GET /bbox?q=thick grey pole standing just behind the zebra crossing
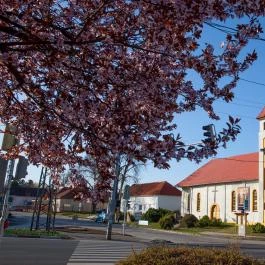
[106,155,120,240]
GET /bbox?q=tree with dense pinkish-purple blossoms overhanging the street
[0,0,265,188]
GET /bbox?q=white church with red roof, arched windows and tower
[177,108,265,224]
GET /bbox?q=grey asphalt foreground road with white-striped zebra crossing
[0,237,145,265]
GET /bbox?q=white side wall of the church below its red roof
[181,181,262,223]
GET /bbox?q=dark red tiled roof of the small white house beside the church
[130,181,181,196]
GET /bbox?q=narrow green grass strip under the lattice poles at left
[4,228,65,238]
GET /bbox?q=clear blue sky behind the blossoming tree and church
[21,17,265,185]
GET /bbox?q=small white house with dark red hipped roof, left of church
[122,181,181,218]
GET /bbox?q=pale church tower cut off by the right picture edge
[257,107,265,224]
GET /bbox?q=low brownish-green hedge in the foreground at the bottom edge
[117,246,264,265]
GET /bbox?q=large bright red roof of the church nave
[177,152,259,187]
